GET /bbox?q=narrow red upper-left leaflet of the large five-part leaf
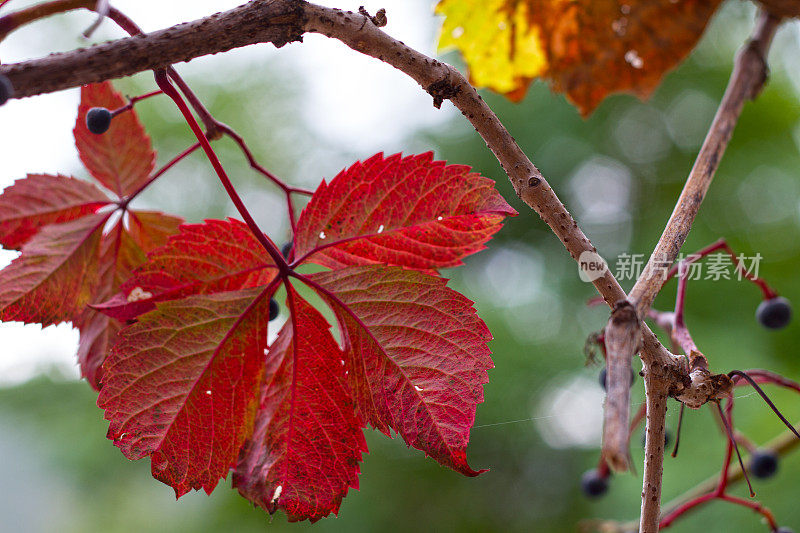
[95,219,275,320]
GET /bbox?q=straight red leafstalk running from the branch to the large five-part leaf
[155,70,289,270]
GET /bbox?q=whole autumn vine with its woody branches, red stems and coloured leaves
[0,0,800,533]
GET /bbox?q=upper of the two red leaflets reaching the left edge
[0,174,109,250]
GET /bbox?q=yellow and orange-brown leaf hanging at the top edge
[436,0,720,115]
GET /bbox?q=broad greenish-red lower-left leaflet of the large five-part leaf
[97,288,271,496]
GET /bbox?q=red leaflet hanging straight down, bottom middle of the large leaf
[233,286,367,522]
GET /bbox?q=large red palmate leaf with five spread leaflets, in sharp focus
[97,154,514,521]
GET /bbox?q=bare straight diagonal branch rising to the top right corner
[630,13,780,316]
